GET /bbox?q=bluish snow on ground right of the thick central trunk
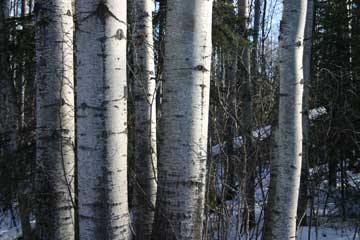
[208,164,360,240]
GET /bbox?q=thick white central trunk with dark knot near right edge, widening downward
[152,0,212,240]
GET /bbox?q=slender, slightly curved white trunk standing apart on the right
[264,0,307,240]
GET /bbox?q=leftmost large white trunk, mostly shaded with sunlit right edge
[35,0,75,240]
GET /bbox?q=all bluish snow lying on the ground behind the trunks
[0,164,360,240]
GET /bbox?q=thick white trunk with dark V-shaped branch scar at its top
[76,0,129,240]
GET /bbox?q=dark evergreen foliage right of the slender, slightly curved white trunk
[310,0,360,219]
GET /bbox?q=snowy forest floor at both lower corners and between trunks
[0,163,360,240]
